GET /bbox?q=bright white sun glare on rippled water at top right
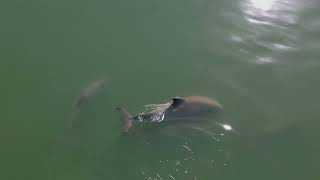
[236,0,304,64]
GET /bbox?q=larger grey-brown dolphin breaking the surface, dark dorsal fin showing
[117,96,223,135]
